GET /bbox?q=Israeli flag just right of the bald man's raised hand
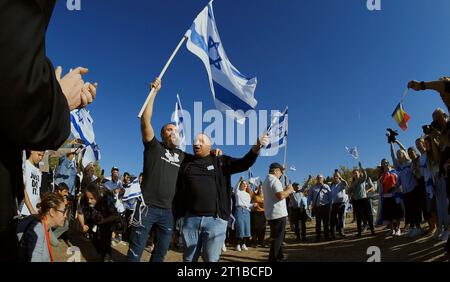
[261,108,288,156]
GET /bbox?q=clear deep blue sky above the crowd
[47,0,450,184]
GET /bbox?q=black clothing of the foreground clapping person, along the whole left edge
[0,0,70,261]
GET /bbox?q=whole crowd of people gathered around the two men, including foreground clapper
[0,0,450,262]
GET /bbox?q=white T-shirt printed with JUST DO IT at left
[20,160,42,215]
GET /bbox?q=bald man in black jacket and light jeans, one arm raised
[174,134,269,262]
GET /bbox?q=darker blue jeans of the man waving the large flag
[127,202,173,262]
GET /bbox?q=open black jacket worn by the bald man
[173,150,258,221]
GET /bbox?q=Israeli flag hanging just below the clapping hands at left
[70,109,95,145]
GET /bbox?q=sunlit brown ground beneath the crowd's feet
[54,215,448,262]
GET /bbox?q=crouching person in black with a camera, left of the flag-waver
[78,183,120,262]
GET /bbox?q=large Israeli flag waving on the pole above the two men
[186,1,258,124]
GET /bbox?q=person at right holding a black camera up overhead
[390,133,422,237]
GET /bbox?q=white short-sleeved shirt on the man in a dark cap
[263,174,288,220]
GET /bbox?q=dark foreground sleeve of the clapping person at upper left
[0,0,70,150]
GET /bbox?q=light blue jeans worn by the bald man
[182,215,228,262]
